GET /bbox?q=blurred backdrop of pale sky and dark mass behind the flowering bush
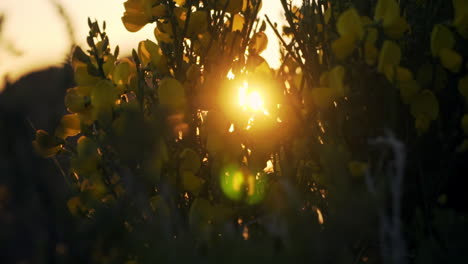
[0,0,292,264]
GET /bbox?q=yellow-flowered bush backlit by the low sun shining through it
[33,0,468,263]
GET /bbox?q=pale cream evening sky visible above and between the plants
[0,0,296,91]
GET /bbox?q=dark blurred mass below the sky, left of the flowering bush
[0,64,74,263]
